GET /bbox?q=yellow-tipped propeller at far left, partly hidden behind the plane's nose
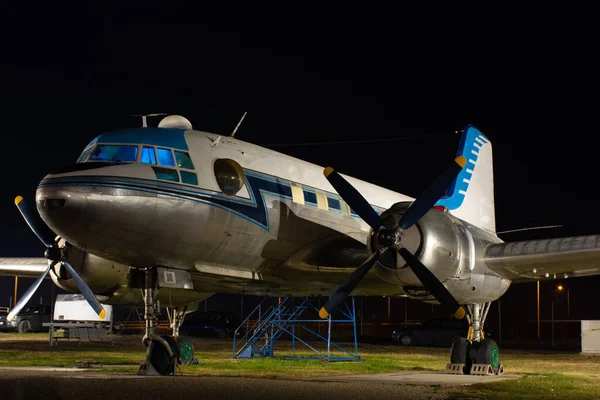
[6,196,106,321]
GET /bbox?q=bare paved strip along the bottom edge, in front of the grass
[0,368,509,400]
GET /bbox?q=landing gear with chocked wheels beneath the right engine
[446,303,504,375]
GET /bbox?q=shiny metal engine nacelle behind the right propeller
[369,203,510,304]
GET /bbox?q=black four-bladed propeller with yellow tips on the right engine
[319,156,467,318]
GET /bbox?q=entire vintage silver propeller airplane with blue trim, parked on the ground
[0,115,600,374]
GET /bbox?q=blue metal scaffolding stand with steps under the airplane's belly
[232,297,361,362]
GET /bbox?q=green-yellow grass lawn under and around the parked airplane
[0,333,600,399]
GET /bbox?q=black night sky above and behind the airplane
[0,2,600,322]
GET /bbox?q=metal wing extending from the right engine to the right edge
[484,235,600,282]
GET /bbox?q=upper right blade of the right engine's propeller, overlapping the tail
[400,156,467,229]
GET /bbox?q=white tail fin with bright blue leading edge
[437,125,496,233]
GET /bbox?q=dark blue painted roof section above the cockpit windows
[88,128,189,150]
